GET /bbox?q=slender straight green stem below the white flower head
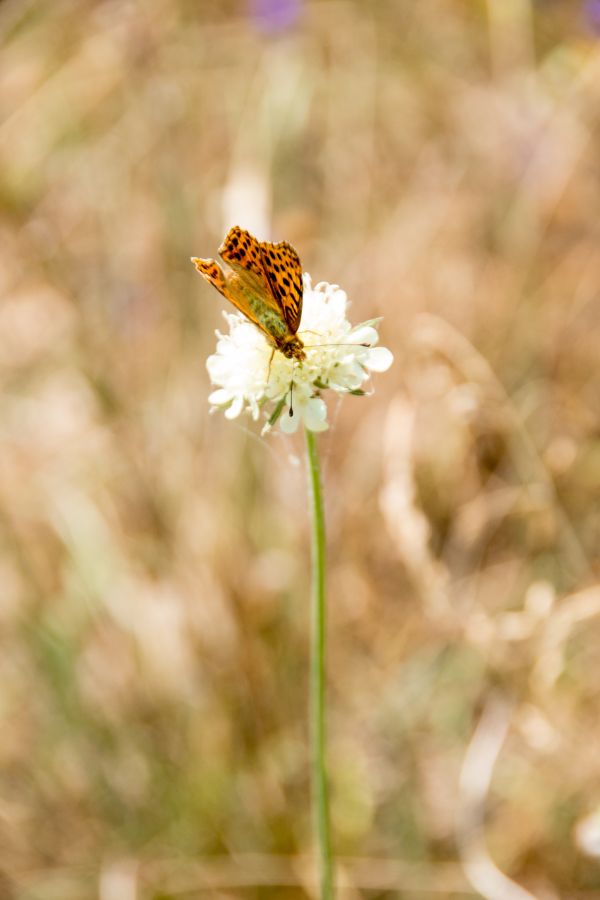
[305,428,333,900]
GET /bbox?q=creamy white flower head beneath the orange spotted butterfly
[206,274,394,434]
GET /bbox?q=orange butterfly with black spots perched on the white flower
[192,225,306,362]
